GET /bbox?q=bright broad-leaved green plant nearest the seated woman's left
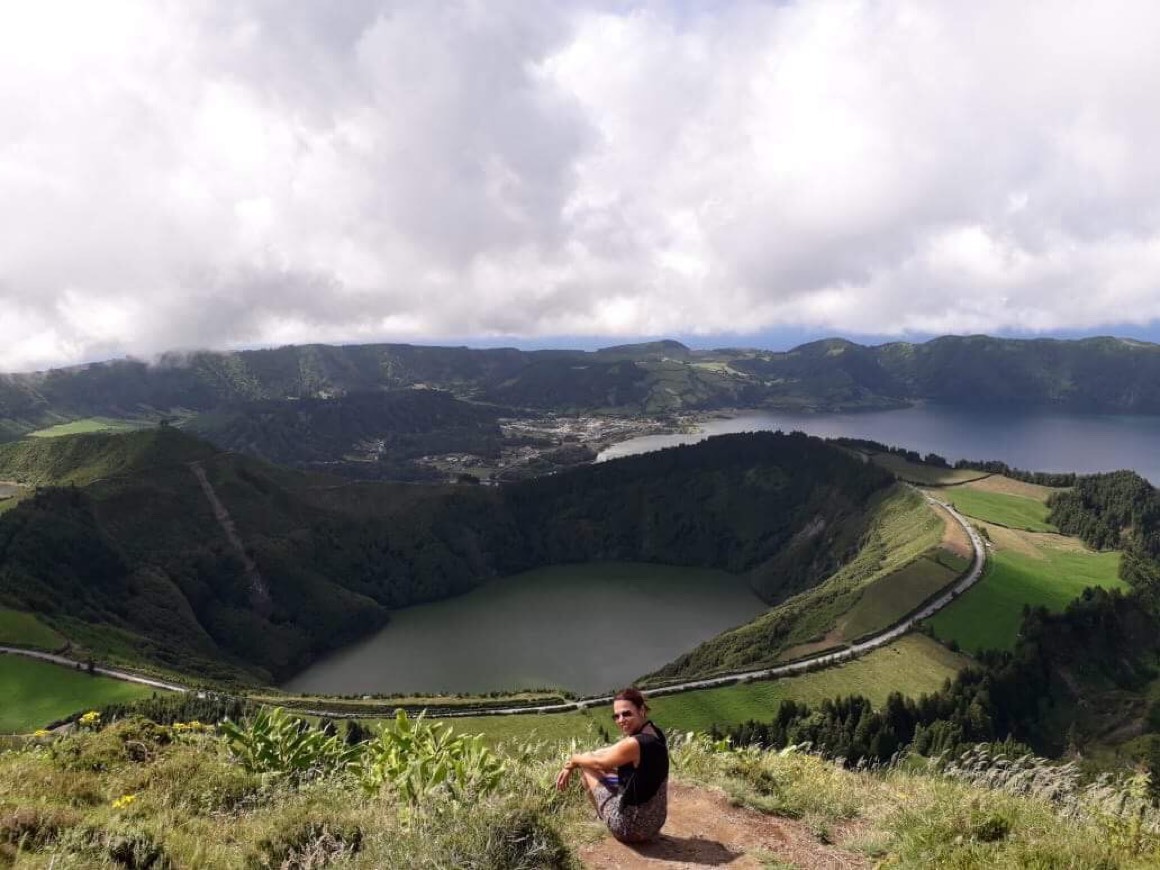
[360,710,507,807]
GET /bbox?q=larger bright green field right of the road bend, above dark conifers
[929,546,1125,652]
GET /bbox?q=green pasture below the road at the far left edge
[0,653,157,733]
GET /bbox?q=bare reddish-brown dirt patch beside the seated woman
[580,783,871,870]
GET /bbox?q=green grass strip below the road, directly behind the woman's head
[444,635,971,741]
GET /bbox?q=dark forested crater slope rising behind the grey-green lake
[0,427,890,679]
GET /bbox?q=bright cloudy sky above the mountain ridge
[0,0,1160,370]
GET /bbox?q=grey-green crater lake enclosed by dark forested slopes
[283,563,764,695]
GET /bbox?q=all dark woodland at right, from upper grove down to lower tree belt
[728,472,1160,792]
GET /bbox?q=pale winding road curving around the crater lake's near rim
[0,495,987,718]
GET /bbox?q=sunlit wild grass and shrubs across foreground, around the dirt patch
[0,720,1160,870]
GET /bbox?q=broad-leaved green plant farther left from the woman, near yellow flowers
[219,708,362,778]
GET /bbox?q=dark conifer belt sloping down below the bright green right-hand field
[723,589,1160,774]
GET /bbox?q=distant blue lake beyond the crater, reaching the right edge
[600,405,1160,484]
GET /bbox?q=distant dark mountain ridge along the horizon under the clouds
[0,335,1160,437]
